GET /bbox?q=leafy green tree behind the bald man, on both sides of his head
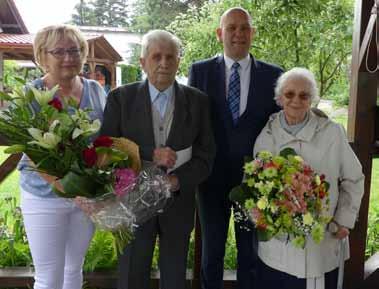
[169,0,353,96]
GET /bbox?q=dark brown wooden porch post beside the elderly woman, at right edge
[344,0,379,289]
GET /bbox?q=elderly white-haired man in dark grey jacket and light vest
[101,30,215,289]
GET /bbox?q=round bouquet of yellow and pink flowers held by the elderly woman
[230,148,330,248]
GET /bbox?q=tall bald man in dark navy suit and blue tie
[189,7,282,289]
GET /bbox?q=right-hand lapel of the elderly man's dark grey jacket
[166,81,188,147]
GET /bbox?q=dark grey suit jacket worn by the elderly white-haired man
[101,81,215,196]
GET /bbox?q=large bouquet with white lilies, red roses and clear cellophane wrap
[0,86,171,251]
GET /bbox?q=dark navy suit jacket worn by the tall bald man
[188,56,282,192]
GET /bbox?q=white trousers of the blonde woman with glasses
[21,192,94,289]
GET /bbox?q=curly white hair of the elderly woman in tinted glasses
[274,67,320,106]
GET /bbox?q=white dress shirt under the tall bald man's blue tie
[224,54,251,116]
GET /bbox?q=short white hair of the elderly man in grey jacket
[141,29,182,58]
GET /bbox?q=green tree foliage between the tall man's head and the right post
[253,0,353,97]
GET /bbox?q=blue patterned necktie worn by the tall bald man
[227,62,241,125]
